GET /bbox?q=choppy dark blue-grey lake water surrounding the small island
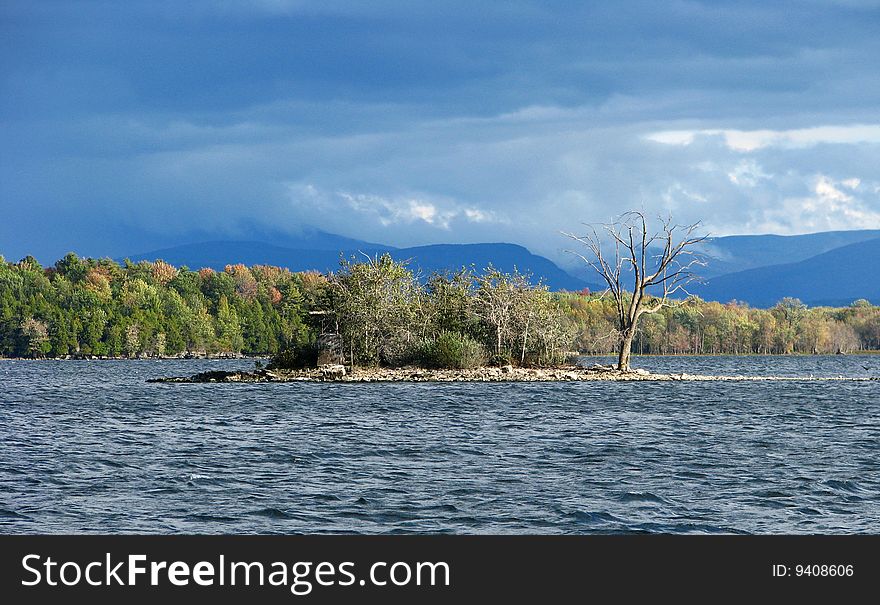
[0,356,880,533]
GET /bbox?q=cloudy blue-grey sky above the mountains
[0,0,880,261]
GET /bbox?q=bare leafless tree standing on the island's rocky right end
[564,211,706,371]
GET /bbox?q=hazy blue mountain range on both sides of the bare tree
[120,229,880,307]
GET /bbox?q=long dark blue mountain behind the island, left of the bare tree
[122,239,597,290]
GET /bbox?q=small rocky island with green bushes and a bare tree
[150,212,870,383]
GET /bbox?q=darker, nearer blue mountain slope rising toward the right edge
[690,237,880,307]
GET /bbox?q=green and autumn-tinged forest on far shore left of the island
[0,254,316,357]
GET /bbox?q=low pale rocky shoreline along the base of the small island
[147,365,880,383]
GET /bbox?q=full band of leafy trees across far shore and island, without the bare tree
[0,254,880,367]
